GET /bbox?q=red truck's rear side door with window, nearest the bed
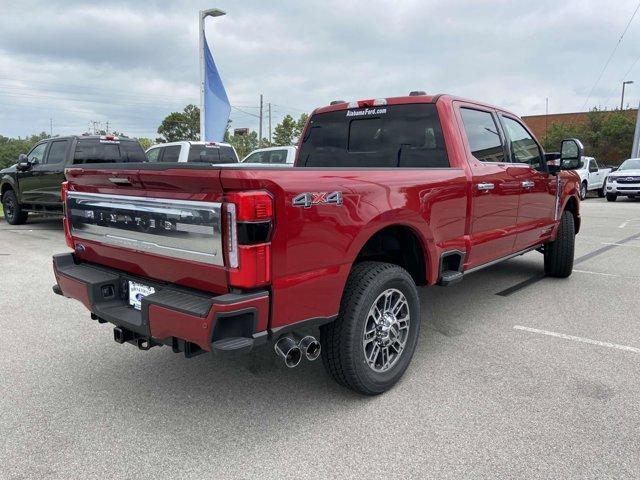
[459,104,521,268]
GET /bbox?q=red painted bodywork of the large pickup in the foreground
[60,96,577,334]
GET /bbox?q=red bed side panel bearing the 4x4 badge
[220,168,467,328]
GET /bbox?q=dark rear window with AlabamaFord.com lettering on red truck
[299,104,449,168]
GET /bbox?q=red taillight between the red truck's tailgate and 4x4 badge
[225,191,273,288]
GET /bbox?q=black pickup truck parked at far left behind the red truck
[0,135,146,225]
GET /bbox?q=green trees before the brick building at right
[544,108,635,165]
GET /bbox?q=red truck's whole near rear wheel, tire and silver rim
[320,262,420,395]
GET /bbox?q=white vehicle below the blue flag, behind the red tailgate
[146,141,238,163]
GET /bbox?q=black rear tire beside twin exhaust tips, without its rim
[320,262,420,395]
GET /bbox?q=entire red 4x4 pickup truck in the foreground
[53,92,583,395]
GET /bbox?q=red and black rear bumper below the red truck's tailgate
[53,253,269,355]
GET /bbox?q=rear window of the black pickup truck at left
[73,138,147,164]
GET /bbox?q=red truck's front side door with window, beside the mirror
[500,114,558,251]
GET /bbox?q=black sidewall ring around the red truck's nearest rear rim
[350,269,420,392]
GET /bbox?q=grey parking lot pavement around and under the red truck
[0,198,640,479]
